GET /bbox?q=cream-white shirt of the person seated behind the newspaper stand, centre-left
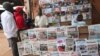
[35,15,48,27]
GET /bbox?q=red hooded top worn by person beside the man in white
[14,7,26,30]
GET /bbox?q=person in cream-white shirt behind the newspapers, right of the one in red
[35,8,48,27]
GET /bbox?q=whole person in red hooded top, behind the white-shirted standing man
[14,7,27,41]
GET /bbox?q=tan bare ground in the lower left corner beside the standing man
[0,30,12,56]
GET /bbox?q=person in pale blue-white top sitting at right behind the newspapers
[71,12,86,26]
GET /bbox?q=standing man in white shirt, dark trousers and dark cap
[1,2,19,56]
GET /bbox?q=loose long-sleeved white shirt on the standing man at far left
[1,11,17,38]
